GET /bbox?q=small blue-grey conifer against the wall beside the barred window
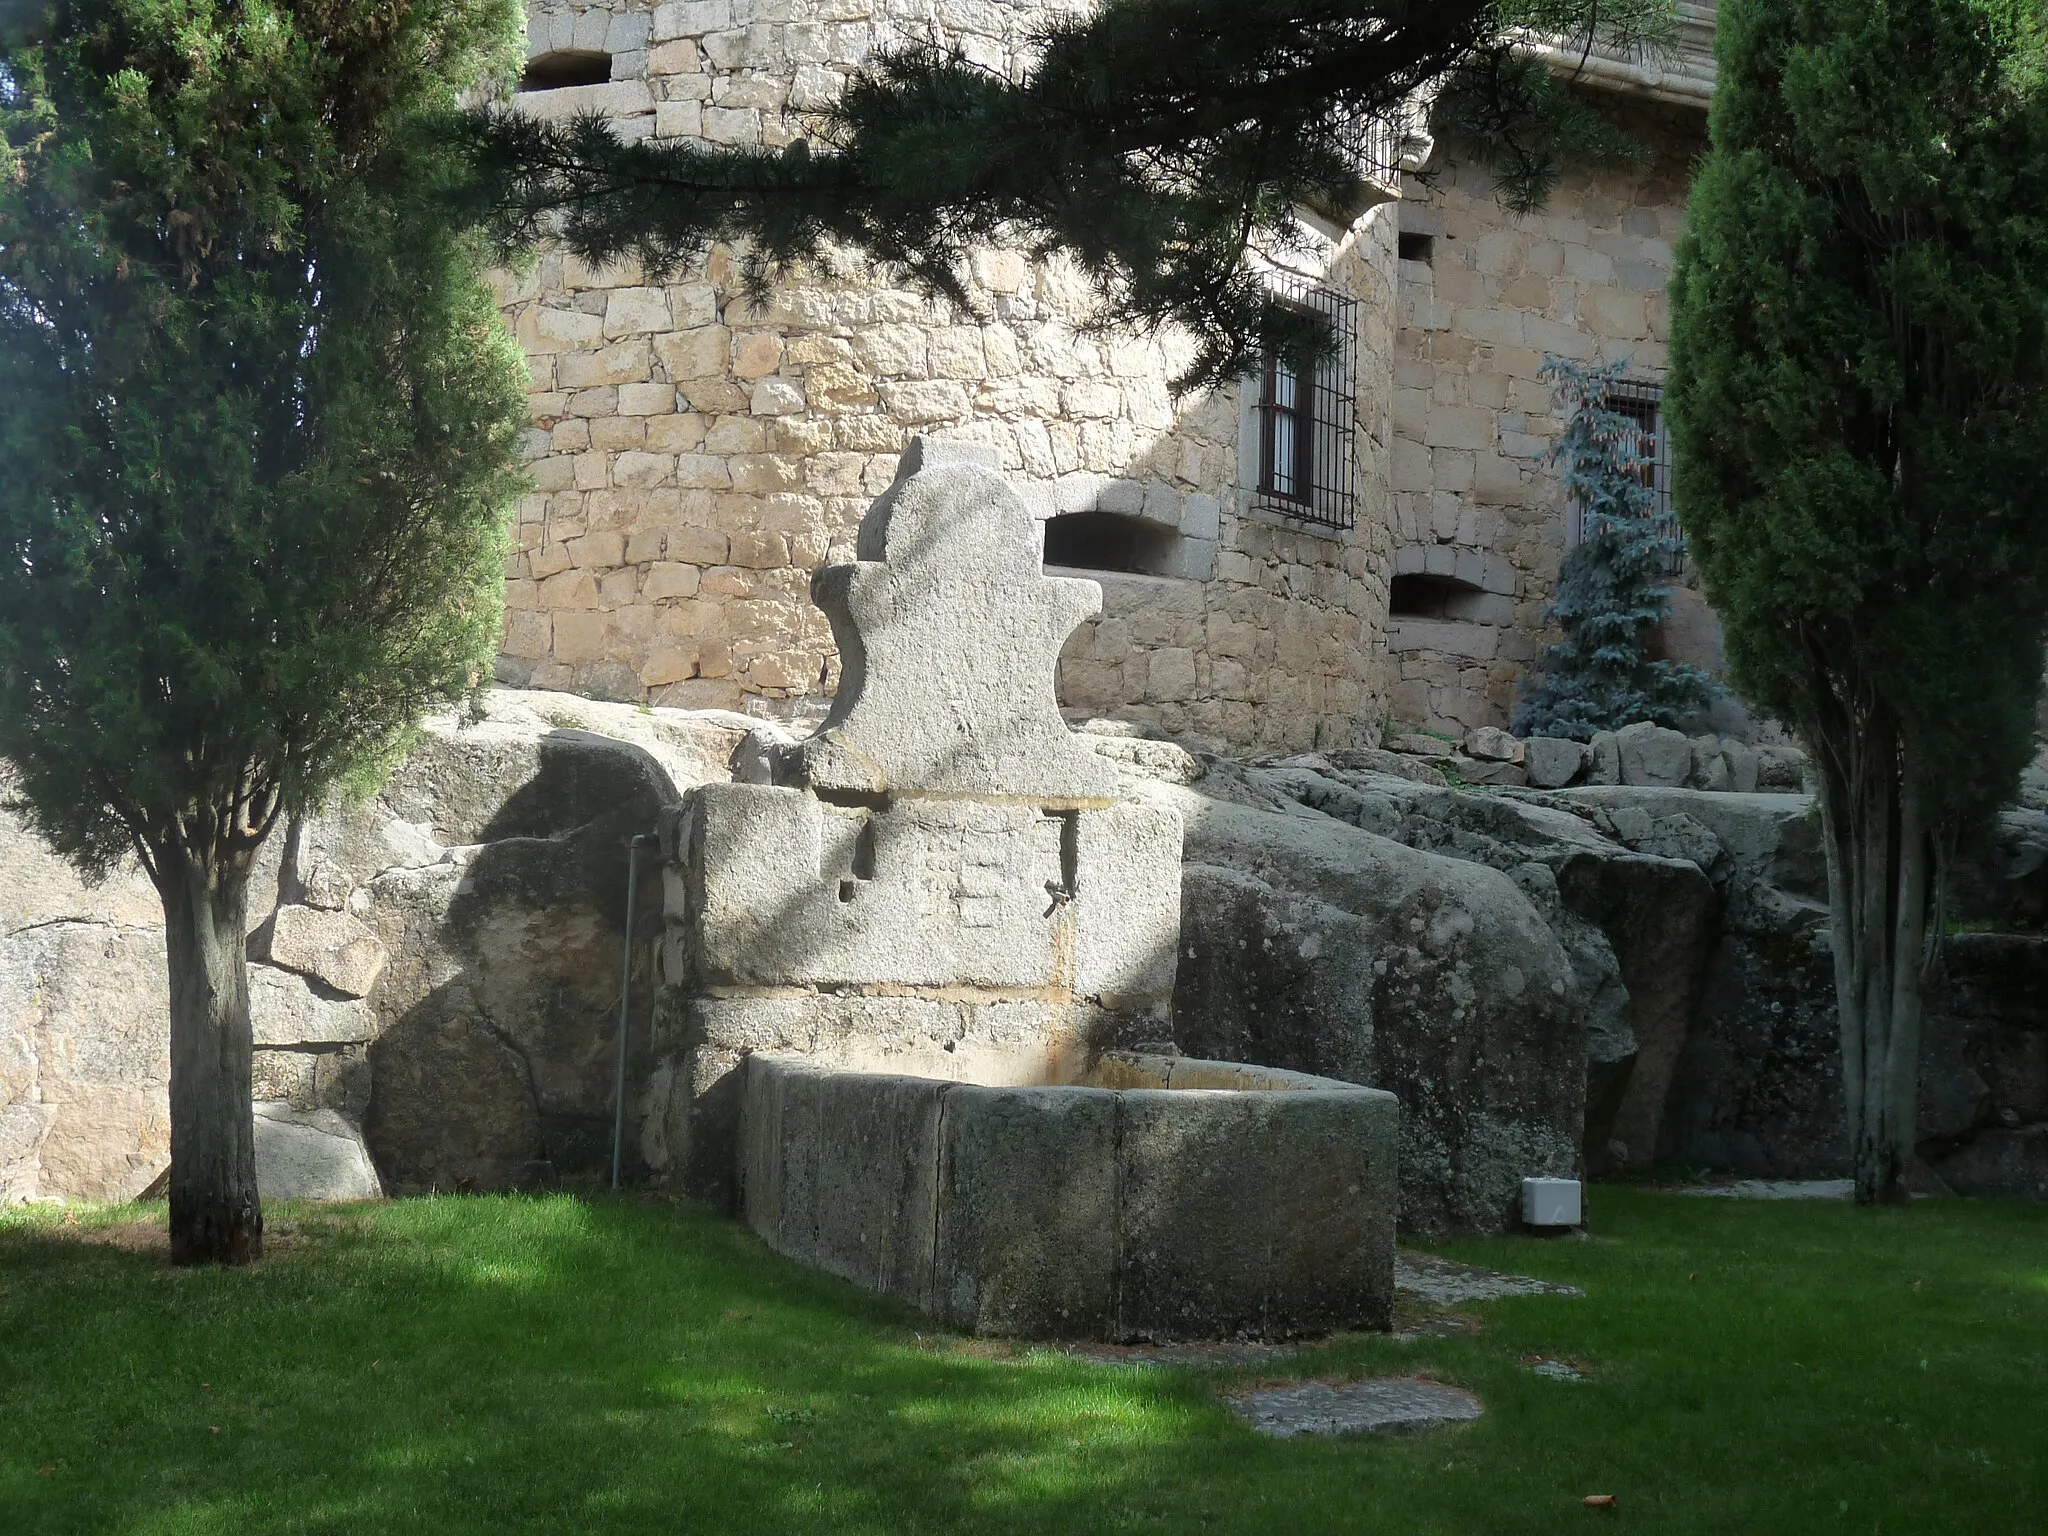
[1513,356,1714,741]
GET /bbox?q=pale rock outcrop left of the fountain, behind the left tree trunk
[0,692,752,1200]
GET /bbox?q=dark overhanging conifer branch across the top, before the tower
[469,0,1671,387]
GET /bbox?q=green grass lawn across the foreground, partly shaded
[0,1190,2048,1536]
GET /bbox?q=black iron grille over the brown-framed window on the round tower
[1253,274,1358,528]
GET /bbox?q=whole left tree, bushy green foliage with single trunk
[0,0,526,1262]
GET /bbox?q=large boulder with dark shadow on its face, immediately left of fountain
[335,692,752,1192]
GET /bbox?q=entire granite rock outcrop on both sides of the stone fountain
[12,692,2048,1231]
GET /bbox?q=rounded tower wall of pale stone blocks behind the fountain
[500,0,1395,745]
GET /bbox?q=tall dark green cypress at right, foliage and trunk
[1667,0,2048,1202]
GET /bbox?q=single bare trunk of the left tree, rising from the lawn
[156,858,262,1264]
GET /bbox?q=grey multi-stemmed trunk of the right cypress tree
[1817,711,1935,1204]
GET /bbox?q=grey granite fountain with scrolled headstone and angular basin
[662,438,1397,1339]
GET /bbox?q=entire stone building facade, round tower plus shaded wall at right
[500,0,1712,750]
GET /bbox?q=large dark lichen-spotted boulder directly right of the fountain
[1151,776,1585,1235]
